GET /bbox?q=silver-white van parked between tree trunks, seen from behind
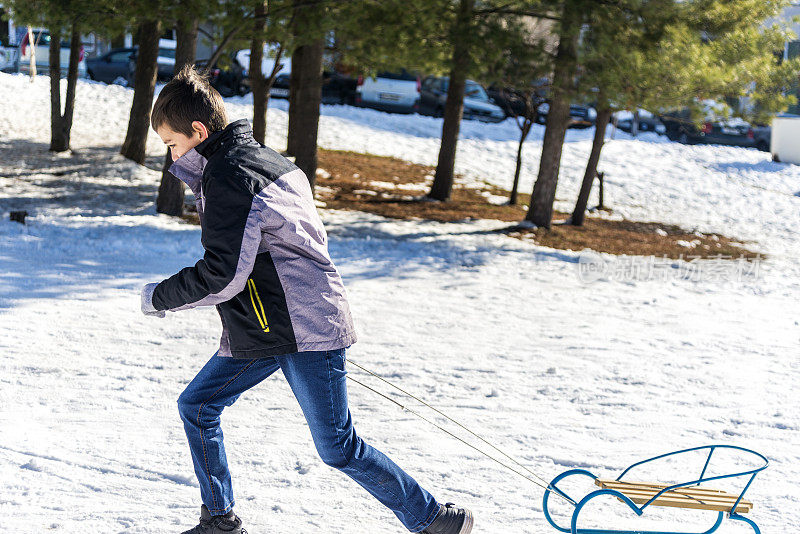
[355,70,420,113]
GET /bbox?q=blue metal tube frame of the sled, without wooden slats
[542,445,769,534]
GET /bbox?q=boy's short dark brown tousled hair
[150,65,228,136]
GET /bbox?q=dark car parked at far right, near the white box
[660,110,769,149]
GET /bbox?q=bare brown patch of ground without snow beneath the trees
[316,150,757,259]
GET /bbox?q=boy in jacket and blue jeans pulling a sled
[141,67,472,534]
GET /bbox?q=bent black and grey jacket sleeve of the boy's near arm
[152,176,261,311]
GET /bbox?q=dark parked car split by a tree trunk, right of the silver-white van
[417,76,506,122]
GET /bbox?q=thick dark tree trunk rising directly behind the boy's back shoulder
[287,39,325,189]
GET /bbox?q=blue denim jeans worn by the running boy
[178,349,439,532]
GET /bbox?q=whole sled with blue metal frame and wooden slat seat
[542,445,769,534]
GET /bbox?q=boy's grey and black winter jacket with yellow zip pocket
[145,120,356,358]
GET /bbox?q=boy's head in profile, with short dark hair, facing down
[150,65,228,161]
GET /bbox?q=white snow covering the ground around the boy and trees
[0,74,800,534]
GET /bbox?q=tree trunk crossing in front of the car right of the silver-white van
[428,0,475,201]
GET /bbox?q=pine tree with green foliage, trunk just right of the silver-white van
[337,0,557,201]
